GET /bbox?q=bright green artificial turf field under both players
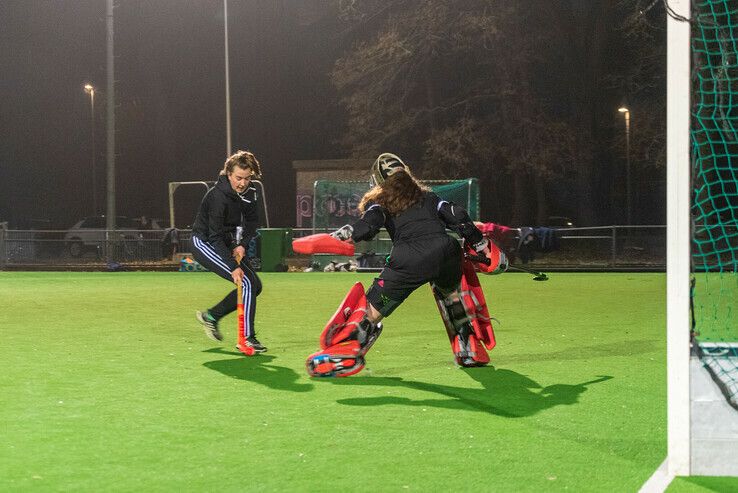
[0,272,732,492]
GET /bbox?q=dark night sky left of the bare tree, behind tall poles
[0,0,344,228]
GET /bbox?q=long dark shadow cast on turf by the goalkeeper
[327,366,613,418]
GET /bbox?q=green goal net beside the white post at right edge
[691,0,738,408]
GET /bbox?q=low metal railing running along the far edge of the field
[0,225,666,270]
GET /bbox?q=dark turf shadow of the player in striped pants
[202,348,314,392]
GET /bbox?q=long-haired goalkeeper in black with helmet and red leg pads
[307,153,498,376]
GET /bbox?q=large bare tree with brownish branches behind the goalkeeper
[331,0,663,224]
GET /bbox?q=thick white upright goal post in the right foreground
[666,0,691,477]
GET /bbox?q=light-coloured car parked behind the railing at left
[64,216,162,257]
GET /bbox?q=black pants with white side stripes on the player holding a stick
[192,235,261,337]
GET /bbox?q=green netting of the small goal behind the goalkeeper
[313,178,479,229]
